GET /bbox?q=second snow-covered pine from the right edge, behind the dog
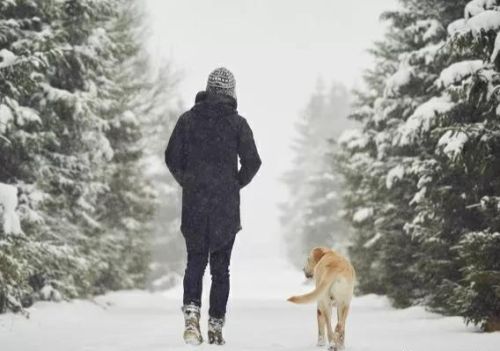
[338,0,464,306]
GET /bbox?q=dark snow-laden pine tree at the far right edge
[419,0,500,331]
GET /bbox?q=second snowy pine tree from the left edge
[36,0,124,297]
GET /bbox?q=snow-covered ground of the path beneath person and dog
[0,258,500,351]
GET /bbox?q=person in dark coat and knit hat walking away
[165,67,261,345]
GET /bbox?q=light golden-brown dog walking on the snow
[288,247,356,350]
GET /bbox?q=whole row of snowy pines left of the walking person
[0,0,179,312]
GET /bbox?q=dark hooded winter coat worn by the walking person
[165,93,261,251]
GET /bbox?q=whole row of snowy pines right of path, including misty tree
[284,0,500,331]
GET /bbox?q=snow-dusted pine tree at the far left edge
[0,1,75,312]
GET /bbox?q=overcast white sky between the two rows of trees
[146,0,396,260]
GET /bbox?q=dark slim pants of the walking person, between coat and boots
[183,238,234,318]
